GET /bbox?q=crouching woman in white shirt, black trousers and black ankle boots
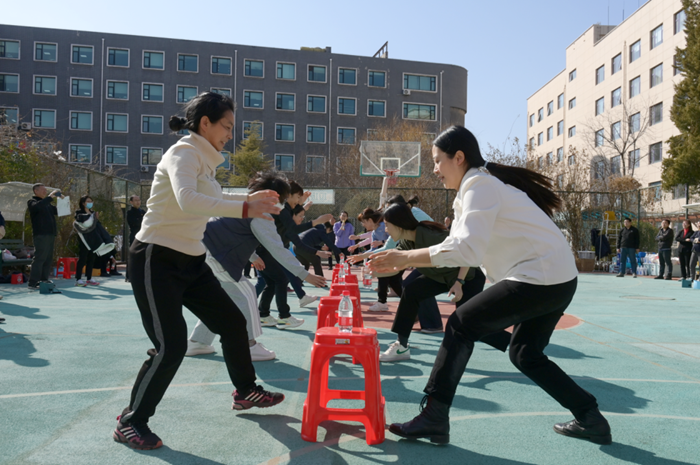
[370,126,612,444]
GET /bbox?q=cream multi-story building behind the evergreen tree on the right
[527,0,685,211]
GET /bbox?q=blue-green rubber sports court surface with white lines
[0,274,700,465]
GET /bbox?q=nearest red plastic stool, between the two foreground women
[301,327,386,445]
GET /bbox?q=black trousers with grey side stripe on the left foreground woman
[122,240,255,423]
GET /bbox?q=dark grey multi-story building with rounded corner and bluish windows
[0,25,467,185]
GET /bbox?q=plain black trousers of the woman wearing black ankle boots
[425,278,598,416]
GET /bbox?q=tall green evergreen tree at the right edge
[661,0,700,190]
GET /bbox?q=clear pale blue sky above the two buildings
[0,0,645,152]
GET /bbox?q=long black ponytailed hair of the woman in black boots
[433,126,561,217]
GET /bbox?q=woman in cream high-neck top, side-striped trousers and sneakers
[113,92,284,450]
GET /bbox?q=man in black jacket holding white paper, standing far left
[27,183,63,290]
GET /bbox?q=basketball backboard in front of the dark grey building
[360,140,421,178]
